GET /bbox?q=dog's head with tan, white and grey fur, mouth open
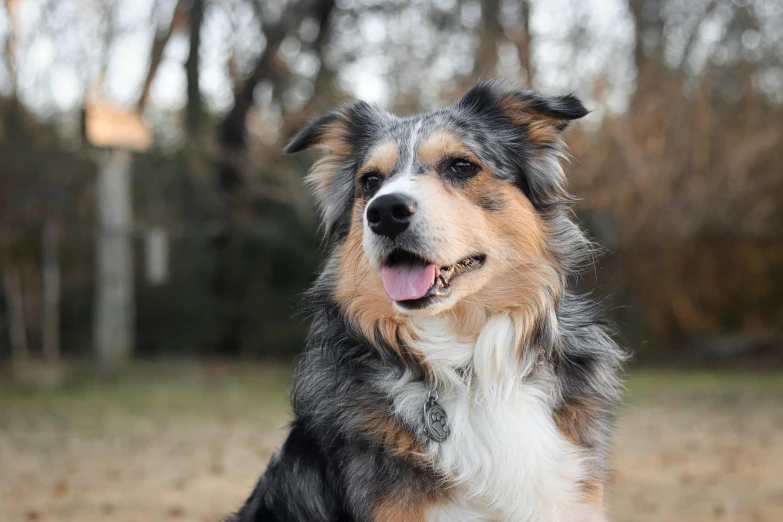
[285,80,587,350]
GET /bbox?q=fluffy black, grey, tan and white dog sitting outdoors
[229,80,625,522]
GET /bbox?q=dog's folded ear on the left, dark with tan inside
[283,101,376,155]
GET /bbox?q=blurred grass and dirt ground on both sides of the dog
[0,367,783,522]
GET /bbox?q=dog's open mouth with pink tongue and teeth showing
[381,250,487,310]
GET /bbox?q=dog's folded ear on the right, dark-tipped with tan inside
[457,79,589,146]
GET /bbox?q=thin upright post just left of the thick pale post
[41,220,60,363]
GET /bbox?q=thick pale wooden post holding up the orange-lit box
[94,148,134,374]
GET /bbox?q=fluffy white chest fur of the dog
[392,315,586,522]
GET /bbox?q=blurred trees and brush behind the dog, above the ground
[0,0,783,365]
